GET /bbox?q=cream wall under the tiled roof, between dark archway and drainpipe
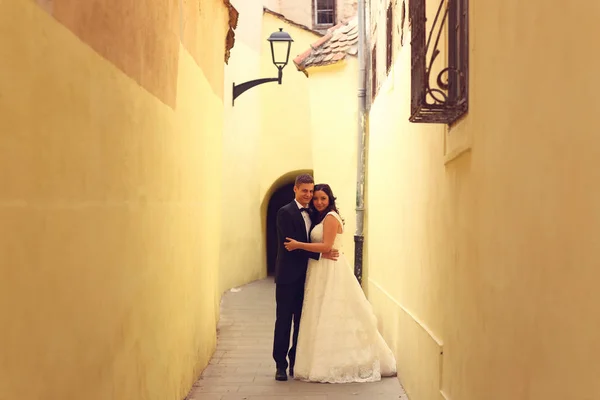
[308,61,358,262]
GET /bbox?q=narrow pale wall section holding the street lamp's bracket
[219,0,266,291]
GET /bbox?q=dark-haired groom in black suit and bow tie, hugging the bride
[273,174,339,381]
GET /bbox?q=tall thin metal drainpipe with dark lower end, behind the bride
[354,0,367,285]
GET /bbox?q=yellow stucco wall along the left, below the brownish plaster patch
[0,0,227,400]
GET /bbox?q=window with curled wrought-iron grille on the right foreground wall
[408,0,469,125]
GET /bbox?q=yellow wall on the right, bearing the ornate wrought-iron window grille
[367,0,600,400]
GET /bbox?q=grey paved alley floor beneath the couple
[187,279,407,400]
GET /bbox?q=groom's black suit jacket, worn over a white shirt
[275,200,321,284]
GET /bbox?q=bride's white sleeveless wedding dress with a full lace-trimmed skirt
[294,211,396,383]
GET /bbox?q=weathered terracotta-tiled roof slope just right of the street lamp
[294,16,358,76]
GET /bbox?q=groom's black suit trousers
[273,279,305,369]
